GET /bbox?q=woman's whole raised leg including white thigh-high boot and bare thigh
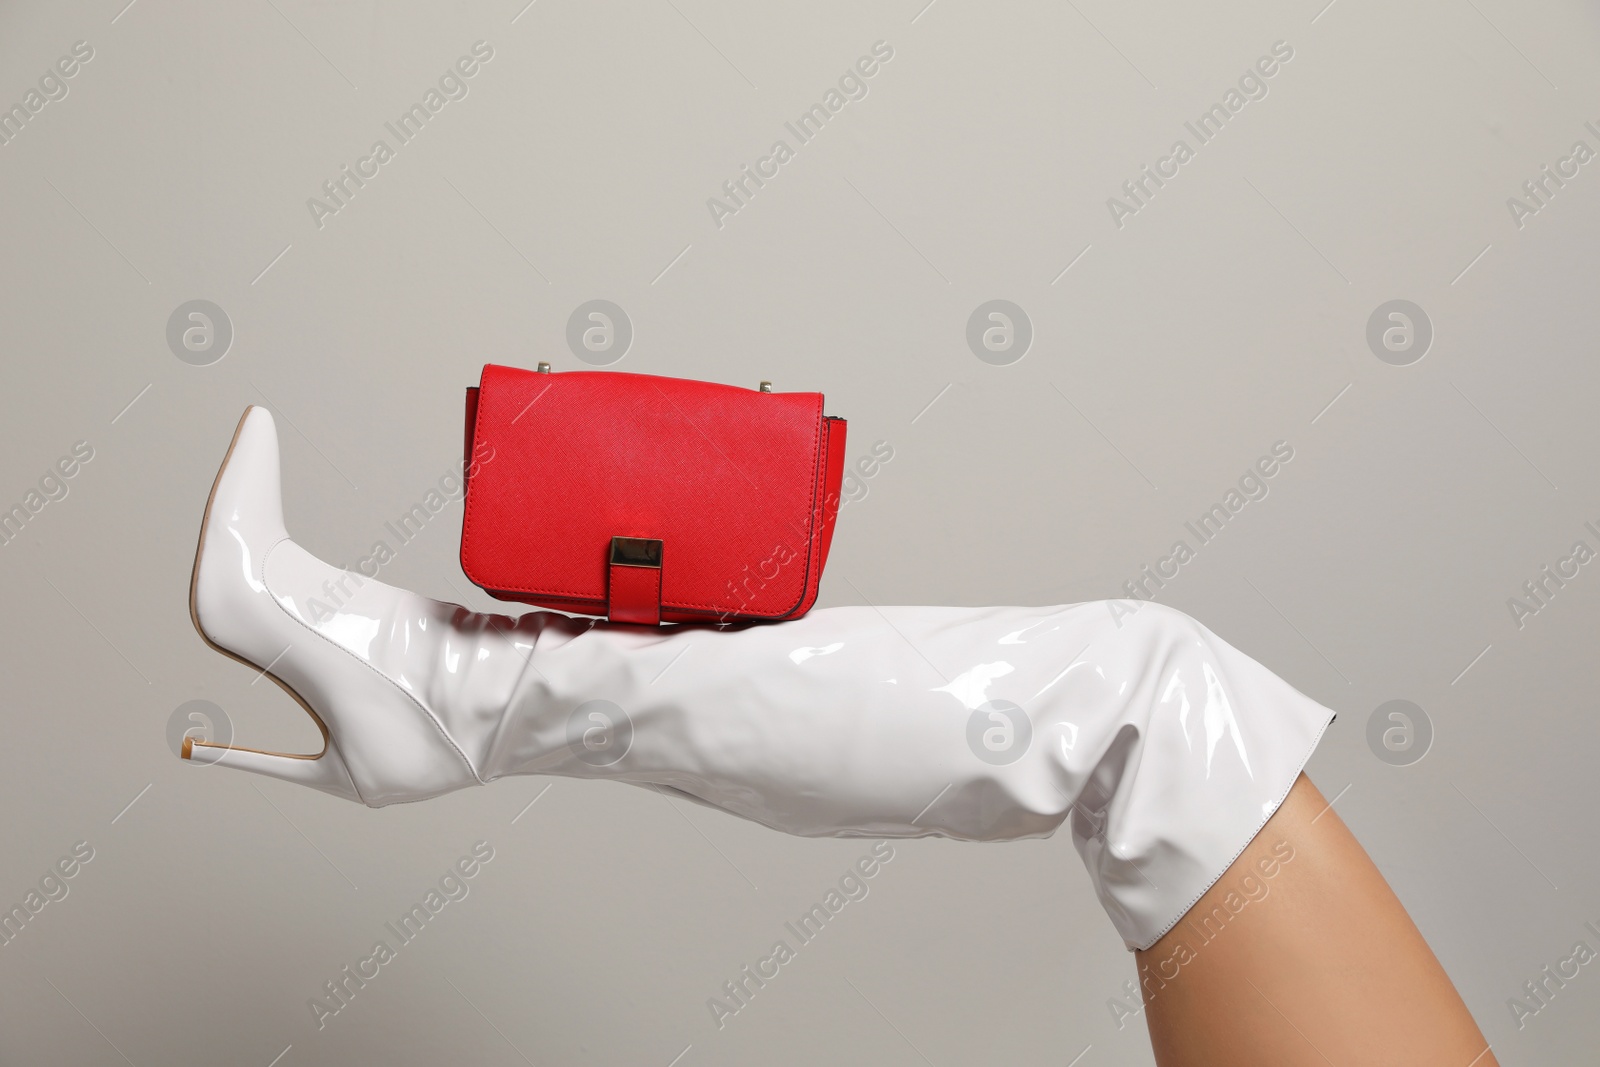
[190,410,1488,1067]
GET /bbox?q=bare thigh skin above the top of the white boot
[1138,774,1498,1067]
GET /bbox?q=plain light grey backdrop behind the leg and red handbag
[0,0,1600,1067]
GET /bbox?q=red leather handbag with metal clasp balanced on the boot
[461,363,845,625]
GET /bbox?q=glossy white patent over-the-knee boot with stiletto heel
[187,408,1333,947]
